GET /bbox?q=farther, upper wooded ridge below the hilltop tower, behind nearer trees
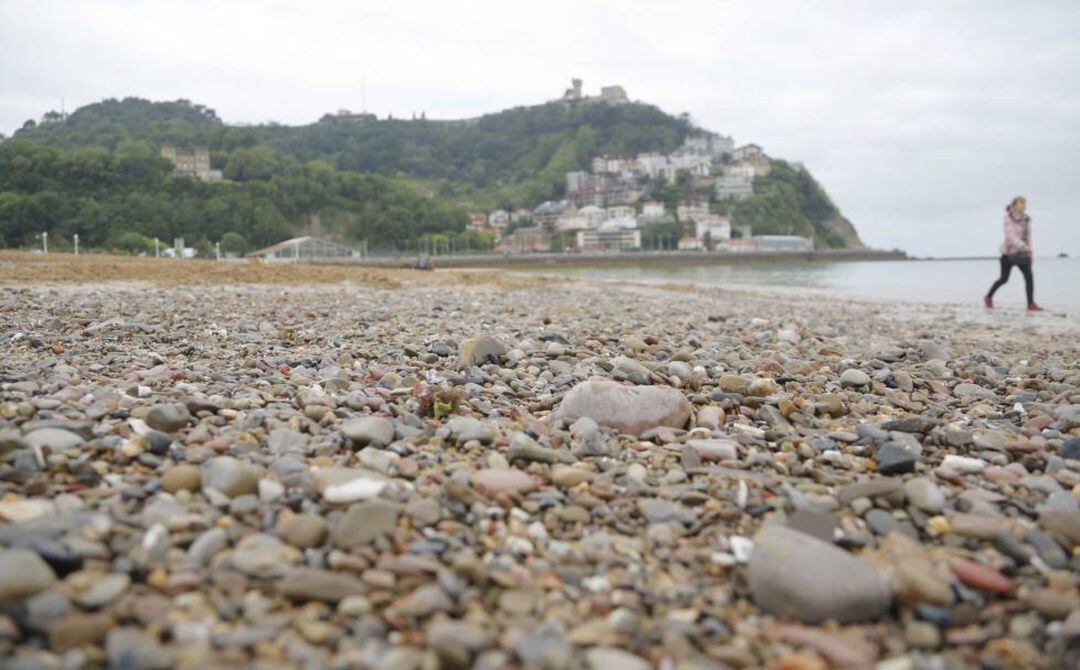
[15,98,693,209]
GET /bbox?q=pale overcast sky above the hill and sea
[0,0,1080,255]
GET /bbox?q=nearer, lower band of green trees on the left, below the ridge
[0,138,473,252]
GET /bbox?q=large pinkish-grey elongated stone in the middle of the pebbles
[558,379,690,436]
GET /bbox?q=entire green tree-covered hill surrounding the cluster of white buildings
[0,98,859,250]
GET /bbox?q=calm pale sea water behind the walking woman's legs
[529,257,1080,313]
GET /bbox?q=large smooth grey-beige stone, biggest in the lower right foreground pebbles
[748,525,892,624]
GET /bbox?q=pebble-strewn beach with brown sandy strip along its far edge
[0,254,1080,670]
